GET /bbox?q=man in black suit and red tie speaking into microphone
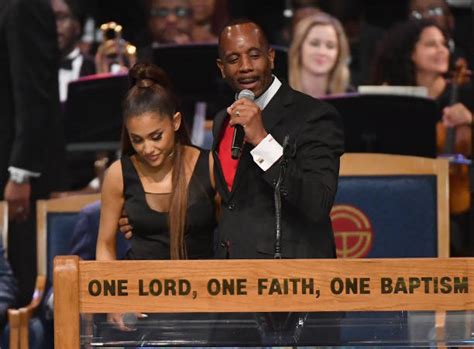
[213,21,343,258]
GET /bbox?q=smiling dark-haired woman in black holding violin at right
[374,19,474,256]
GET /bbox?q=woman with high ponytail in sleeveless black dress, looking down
[97,64,216,330]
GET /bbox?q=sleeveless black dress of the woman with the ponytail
[121,150,216,260]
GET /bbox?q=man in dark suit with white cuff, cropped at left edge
[0,0,62,305]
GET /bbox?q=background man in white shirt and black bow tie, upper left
[51,0,95,102]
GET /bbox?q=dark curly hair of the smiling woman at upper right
[372,19,446,86]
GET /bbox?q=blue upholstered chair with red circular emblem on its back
[331,153,449,341]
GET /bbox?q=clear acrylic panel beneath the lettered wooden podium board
[81,311,474,348]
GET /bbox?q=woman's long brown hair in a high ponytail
[122,63,191,259]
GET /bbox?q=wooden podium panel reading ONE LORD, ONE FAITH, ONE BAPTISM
[75,258,474,313]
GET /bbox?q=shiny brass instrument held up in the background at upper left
[95,22,137,73]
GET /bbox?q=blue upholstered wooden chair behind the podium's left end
[20,194,100,349]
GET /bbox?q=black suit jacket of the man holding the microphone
[213,84,343,258]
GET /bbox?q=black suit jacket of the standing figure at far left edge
[0,0,62,198]
